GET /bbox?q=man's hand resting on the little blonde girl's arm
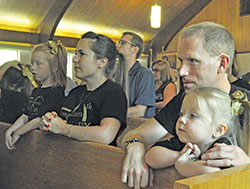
[201,144,250,167]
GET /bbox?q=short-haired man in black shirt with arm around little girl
[118,22,250,188]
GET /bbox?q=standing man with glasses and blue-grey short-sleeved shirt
[116,32,155,118]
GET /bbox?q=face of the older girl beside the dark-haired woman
[31,51,52,85]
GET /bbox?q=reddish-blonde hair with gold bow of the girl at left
[32,41,67,87]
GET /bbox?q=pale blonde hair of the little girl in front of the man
[187,87,237,152]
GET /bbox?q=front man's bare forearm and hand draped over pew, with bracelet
[121,118,168,188]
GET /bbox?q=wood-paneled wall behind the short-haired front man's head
[166,0,250,52]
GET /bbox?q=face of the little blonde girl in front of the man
[176,95,214,147]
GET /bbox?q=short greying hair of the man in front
[181,22,235,72]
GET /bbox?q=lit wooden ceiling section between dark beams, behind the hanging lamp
[56,0,192,42]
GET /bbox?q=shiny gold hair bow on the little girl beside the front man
[232,90,248,116]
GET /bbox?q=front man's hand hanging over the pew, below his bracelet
[121,142,149,189]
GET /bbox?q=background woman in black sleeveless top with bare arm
[152,60,177,112]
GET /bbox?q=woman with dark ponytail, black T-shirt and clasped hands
[43,32,127,146]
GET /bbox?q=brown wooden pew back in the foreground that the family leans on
[0,123,250,189]
